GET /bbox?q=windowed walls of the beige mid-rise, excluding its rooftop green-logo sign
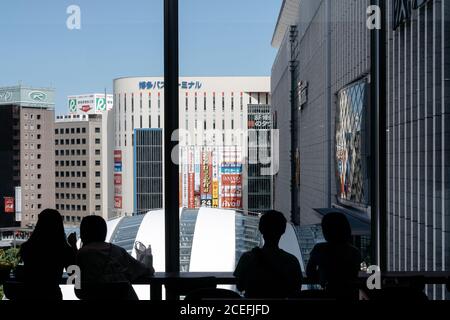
[55,115,107,224]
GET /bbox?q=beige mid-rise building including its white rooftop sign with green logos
[54,94,113,225]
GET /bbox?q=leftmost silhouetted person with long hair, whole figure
[19,209,76,300]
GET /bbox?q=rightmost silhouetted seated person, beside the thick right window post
[306,212,361,297]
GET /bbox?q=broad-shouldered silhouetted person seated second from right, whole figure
[234,211,302,299]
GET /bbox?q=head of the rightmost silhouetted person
[322,212,352,244]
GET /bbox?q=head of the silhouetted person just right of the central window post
[259,210,287,246]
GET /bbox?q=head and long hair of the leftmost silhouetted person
[29,209,66,246]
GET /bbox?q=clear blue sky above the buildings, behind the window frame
[0,0,282,114]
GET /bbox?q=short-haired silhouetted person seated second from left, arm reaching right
[77,216,155,299]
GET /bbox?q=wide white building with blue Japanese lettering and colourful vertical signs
[113,77,270,215]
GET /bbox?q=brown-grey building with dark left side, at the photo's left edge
[0,86,55,227]
